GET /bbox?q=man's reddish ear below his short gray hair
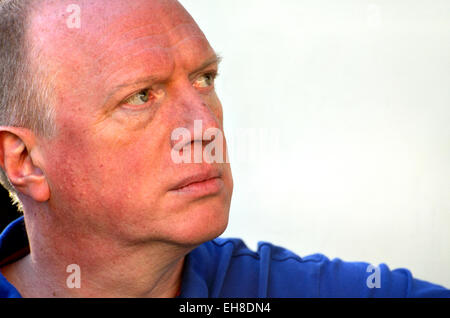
[0,127,50,202]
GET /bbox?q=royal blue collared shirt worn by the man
[0,217,450,298]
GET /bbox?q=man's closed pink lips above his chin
[170,170,224,196]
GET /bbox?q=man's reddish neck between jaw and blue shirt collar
[2,209,192,298]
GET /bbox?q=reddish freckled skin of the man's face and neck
[2,0,233,296]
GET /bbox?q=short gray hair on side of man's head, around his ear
[0,0,55,209]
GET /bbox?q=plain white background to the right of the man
[181,0,450,288]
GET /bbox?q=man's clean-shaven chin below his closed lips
[111,183,231,248]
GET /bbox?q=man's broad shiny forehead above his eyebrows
[29,0,213,87]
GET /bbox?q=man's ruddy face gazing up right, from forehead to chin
[30,0,233,244]
